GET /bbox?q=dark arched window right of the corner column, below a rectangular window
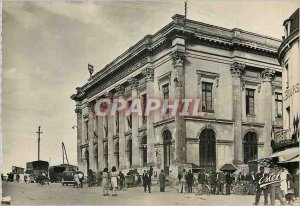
[199,129,216,170]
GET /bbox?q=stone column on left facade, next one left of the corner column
[143,67,155,165]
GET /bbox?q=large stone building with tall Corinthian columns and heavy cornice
[71,14,282,177]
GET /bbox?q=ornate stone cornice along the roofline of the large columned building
[71,15,280,101]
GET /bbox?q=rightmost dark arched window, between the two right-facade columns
[244,132,258,163]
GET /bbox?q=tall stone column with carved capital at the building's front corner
[172,50,186,163]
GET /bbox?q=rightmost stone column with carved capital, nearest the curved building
[260,69,275,157]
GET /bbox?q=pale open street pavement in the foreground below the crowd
[2,182,292,205]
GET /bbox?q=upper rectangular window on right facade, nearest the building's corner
[202,82,213,112]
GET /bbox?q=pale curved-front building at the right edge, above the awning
[273,9,300,151]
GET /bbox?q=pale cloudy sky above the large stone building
[1,0,299,174]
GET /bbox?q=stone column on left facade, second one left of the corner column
[129,77,140,168]
